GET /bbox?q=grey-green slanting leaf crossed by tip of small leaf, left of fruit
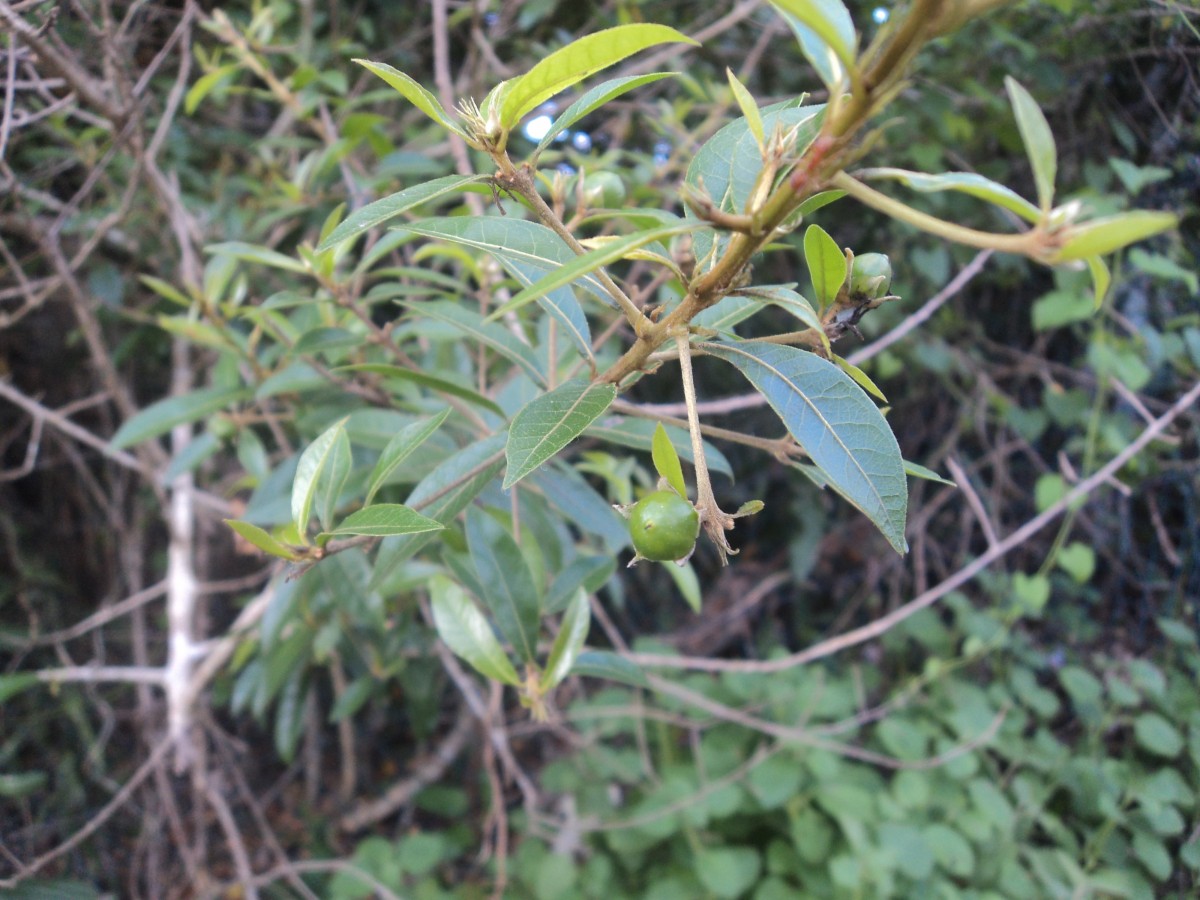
[367,432,506,590]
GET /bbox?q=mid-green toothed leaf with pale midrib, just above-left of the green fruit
[504,378,617,490]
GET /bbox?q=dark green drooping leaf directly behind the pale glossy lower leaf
[467,506,541,662]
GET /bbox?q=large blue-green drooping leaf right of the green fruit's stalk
[697,342,908,553]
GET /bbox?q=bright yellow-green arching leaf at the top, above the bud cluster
[500,24,700,128]
